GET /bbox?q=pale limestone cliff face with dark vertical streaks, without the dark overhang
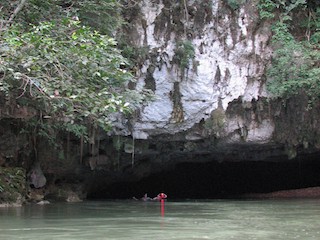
[124,0,274,142]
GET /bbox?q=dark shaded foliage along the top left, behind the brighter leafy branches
[0,0,123,35]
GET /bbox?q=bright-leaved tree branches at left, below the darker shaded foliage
[0,19,132,135]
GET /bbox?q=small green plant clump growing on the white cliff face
[174,40,195,69]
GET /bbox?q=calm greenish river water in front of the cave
[0,199,320,240]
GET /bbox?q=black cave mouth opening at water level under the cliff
[88,158,320,199]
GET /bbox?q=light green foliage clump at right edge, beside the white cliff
[267,23,320,99]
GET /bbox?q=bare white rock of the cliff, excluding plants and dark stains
[129,0,273,143]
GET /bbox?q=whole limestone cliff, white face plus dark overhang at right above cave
[111,0,318,163]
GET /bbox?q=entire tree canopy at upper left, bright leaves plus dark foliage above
[0,0,150,141]
